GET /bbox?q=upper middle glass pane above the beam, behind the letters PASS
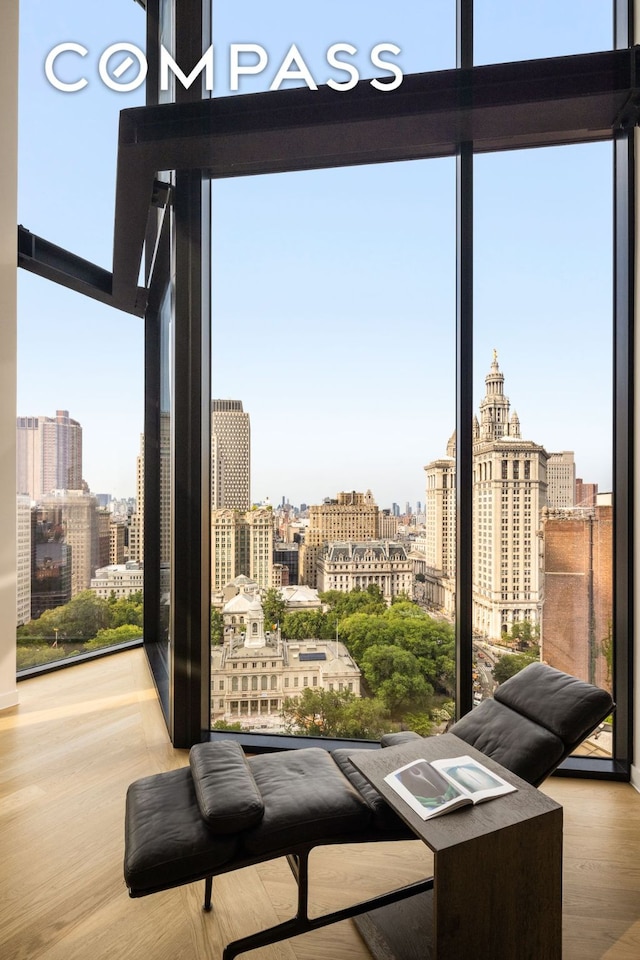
[213,0,456,96]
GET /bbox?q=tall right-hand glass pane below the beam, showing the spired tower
[473,144,615,753]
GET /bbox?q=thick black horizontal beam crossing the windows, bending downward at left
[113,49,637,316]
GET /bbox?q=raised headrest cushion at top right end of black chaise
[494,663,613,749]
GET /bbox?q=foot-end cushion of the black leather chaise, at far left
[124,767,238,897]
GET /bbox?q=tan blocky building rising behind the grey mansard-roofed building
[299,490,380,587]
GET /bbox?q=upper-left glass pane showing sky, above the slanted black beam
[19,0,145,258]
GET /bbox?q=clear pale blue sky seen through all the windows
[18,0,612,507]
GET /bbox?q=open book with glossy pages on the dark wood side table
[384,757,516,820]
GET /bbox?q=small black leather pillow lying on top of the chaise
[189,741,264,833]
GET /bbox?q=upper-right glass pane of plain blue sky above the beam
[473,0,613,64]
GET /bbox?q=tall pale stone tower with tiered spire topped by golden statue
[425,351,549,638]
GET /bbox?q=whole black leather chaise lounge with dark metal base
[124,663,613,960]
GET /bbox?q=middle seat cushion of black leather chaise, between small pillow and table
[240,747,372,855]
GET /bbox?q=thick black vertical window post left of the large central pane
[171,0,211,747]
